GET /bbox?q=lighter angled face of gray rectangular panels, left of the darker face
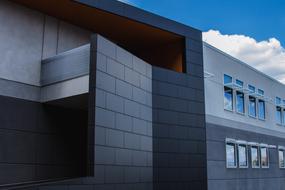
[92,36,153,189]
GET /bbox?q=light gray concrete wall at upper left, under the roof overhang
[0,0,91,86]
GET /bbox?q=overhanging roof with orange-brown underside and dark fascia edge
[12,0,199,72]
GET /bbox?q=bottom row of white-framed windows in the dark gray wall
[226,139,285,168]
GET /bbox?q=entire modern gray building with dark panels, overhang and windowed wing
[0,0,285,190]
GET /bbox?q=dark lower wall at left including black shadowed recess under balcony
[0,96,87,188]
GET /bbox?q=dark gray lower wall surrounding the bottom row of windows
[207,123,285,190]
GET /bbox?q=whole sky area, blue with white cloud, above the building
[117,0,285,83]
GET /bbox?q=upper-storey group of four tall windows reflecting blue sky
[224,74,265,120]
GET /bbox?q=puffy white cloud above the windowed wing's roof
[203,30,285,83]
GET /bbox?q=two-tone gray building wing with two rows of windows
[203,43,285,190]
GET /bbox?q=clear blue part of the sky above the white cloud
[123,0,285,45]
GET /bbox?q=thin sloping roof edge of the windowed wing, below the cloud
[203,41,285,87]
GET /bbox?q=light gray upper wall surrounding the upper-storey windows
[203,43,285,132]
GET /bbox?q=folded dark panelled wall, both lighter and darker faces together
[10,30,207,190]
